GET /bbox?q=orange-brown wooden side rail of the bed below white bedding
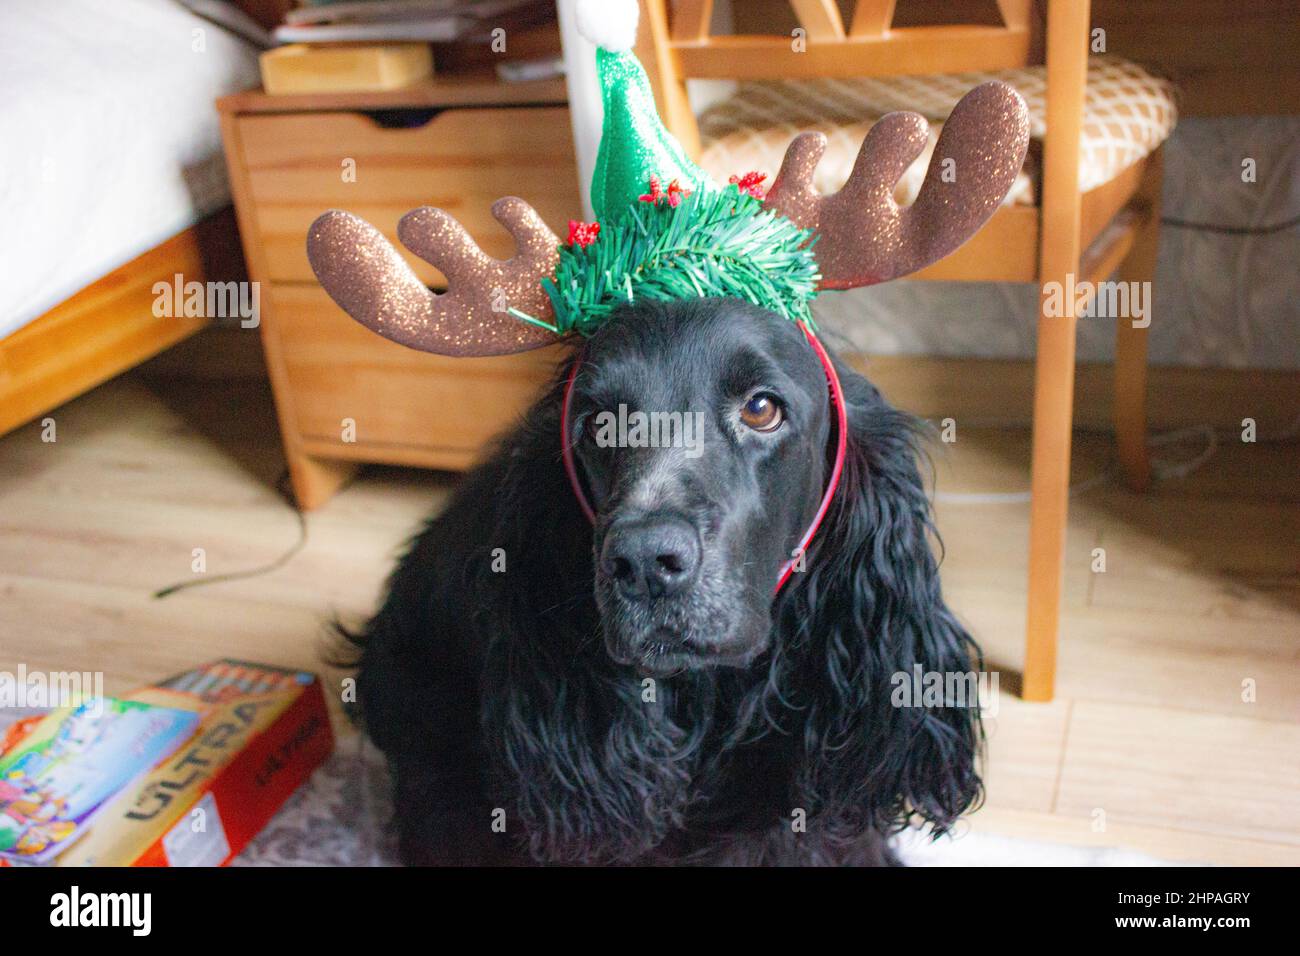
[0,207,246,434]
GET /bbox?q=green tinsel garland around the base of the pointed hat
[510,185,820,336]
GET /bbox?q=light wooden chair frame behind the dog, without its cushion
[637,0,1161,701]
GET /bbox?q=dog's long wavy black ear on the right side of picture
[779,368,983,831]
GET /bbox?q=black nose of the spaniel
[601,518,701,601]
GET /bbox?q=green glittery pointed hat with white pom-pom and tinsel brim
[530,0,819,334]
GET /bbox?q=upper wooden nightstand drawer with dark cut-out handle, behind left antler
[237,107,581,285]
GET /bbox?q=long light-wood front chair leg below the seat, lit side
[1022,300,1075,701]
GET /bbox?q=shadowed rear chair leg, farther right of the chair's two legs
[1115,209,1160,492]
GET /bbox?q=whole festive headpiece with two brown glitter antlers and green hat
[307,0,1030,356]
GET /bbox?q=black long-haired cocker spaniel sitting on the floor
[340,299,982,865]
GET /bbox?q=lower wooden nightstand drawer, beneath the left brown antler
[265,285,564,468]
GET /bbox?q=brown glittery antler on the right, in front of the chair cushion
[766,82,1030,289]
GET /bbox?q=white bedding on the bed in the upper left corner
[0,0,257,338]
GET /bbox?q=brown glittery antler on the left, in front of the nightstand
[307,196,560,356]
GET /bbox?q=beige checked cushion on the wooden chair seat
[699,56,1178,206]
